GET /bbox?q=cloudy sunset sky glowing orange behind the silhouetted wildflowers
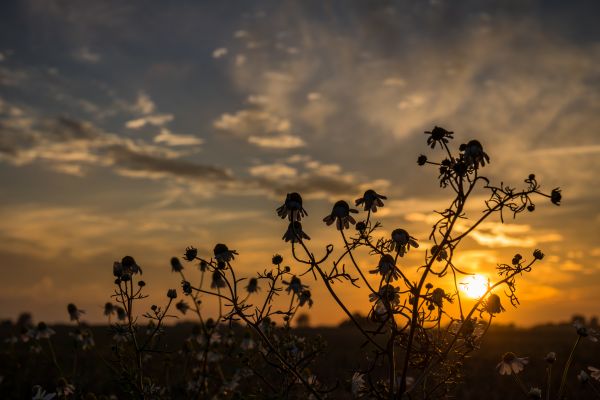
[0,0,600,326]
